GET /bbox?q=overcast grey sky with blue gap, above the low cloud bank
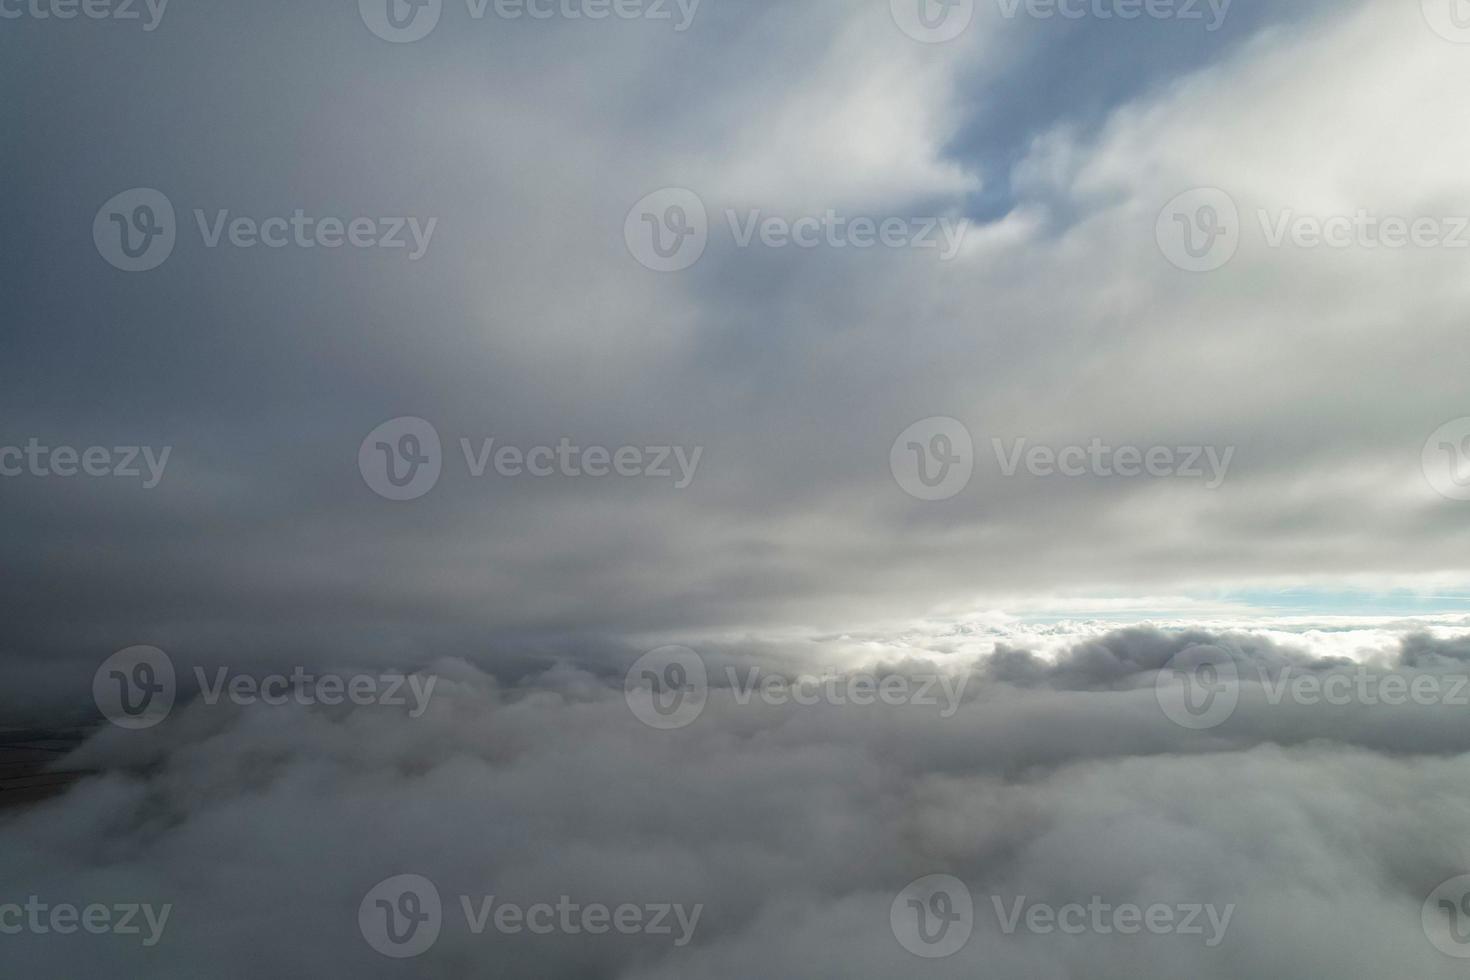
[0,0,1470,705]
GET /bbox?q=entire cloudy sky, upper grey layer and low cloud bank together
[0,0,1470,977]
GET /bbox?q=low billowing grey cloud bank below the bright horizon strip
[0,627,1470,979]
